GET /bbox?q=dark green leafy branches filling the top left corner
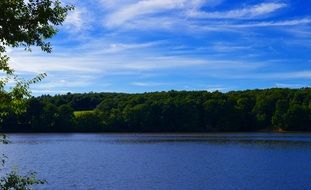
[0,0,72,52]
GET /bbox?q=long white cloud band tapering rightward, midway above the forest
[10,42,263,79]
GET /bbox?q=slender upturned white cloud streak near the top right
[188,3,287,19]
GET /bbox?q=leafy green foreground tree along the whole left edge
[0,0,72,190]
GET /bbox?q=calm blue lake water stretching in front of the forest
[0,133,311,190]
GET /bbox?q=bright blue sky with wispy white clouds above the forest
[8,0,311,95]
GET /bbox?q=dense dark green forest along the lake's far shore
[1,88,311,132]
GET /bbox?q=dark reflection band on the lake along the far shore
[7,133,311,146]
